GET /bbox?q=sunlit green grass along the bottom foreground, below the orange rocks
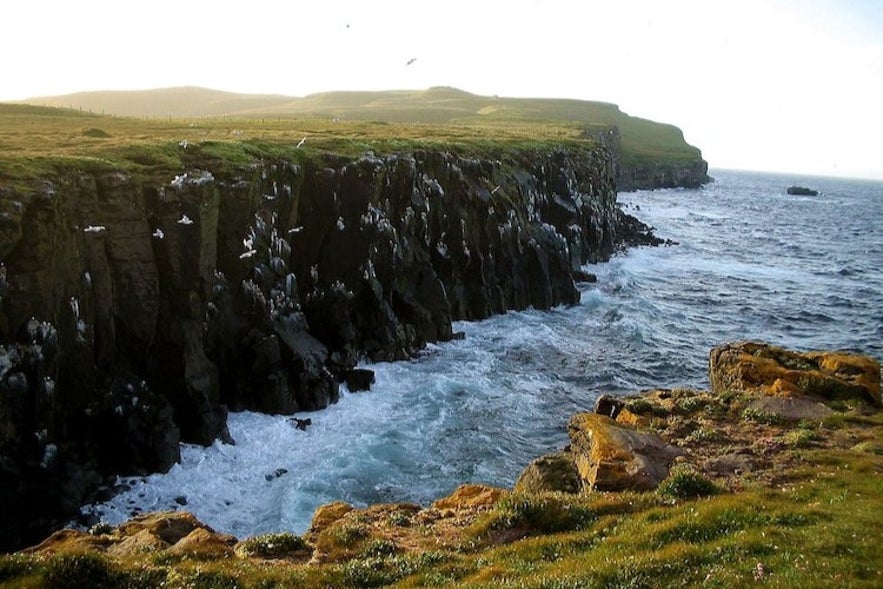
[0,450,883,588]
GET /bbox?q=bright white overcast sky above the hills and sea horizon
[0,0,883,179]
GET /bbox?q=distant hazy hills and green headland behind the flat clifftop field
[20,87,701,161]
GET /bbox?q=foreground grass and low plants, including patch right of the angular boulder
[0,378,883,589]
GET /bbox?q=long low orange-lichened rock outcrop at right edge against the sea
[708,342,881,406]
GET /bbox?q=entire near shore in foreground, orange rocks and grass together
[0,342,883,586]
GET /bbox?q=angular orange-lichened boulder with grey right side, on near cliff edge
[567,413,683,491]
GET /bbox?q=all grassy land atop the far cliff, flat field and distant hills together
[0,88,701,184]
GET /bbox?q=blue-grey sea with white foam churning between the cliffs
[86,171,883,537]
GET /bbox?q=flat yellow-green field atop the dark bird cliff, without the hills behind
[0,104,592,191]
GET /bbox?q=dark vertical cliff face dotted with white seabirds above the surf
[0,149,619,547]
